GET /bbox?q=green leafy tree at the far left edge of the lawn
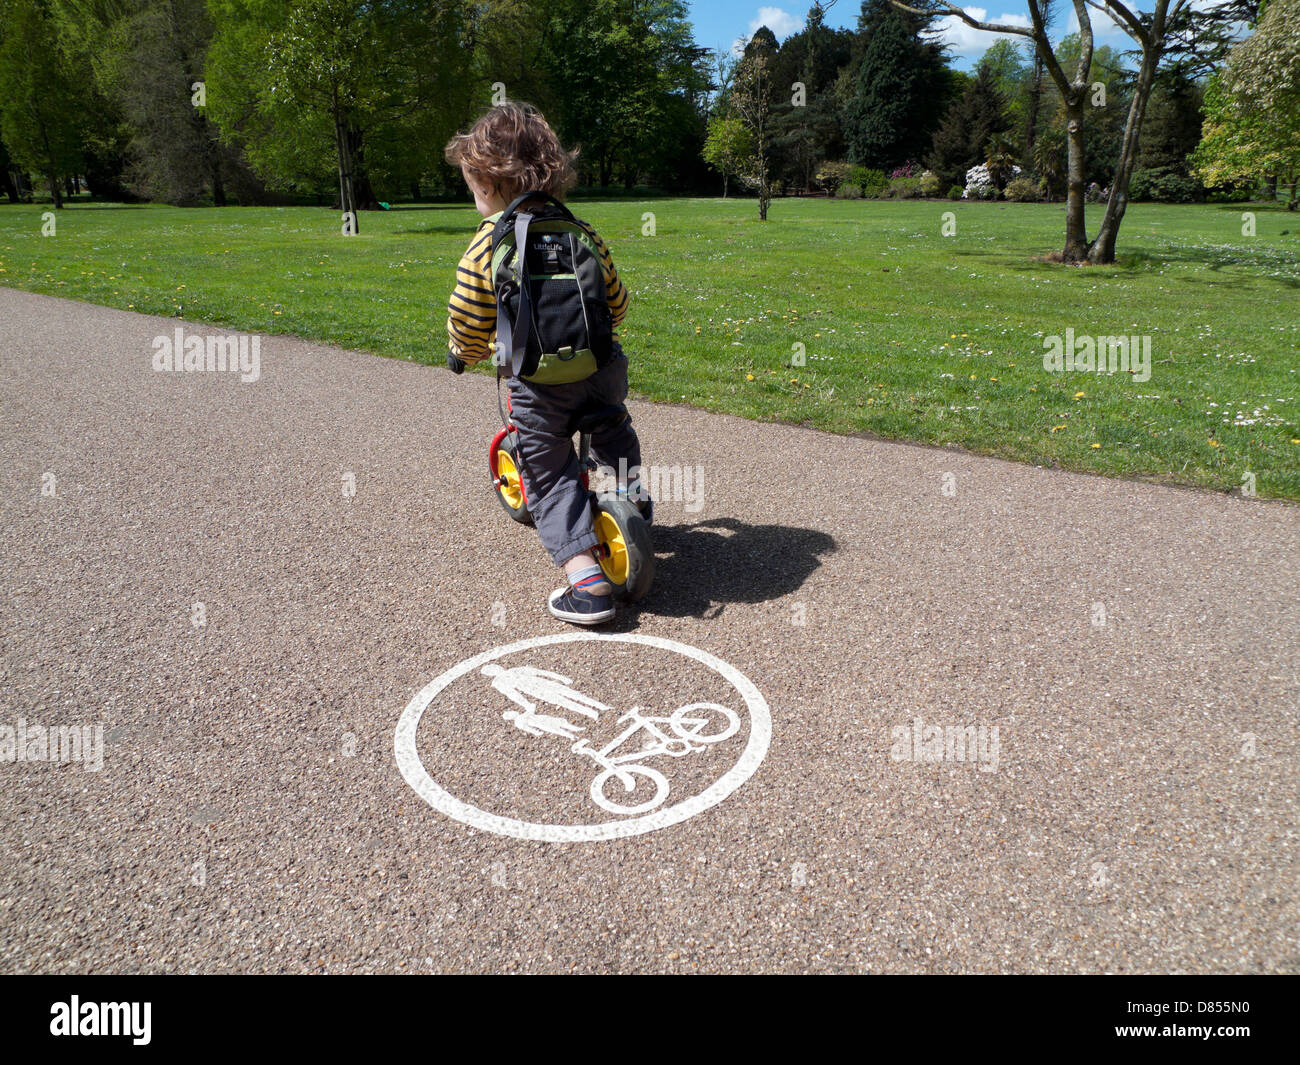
[0,0,87,208]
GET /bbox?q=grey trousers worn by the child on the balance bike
[510,345,641,566]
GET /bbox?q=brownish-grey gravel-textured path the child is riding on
[0,289,1300,973]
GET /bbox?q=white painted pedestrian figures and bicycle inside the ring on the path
[481,663,740,814]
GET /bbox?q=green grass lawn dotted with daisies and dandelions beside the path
[0,199,1300,499]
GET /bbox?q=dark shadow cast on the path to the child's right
[640,518,836,618]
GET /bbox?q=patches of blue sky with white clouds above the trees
[686,0,1145,70]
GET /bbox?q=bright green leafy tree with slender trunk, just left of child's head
[208,0,472,224]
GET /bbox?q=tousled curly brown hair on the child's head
[446,100,577,202]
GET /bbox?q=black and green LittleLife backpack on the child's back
[491,191,614,385]
